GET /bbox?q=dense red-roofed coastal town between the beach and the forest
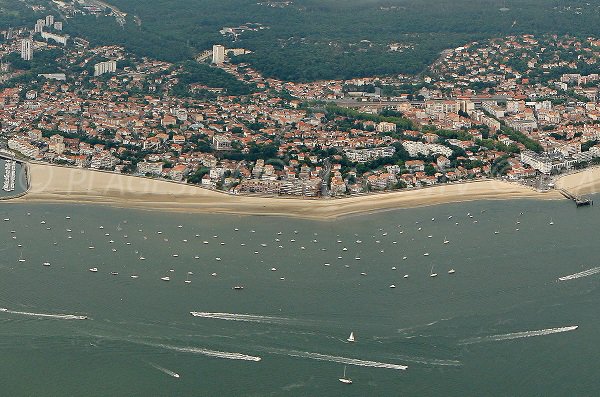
[0,15,600,197]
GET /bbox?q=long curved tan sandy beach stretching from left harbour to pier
[10,164,564,220]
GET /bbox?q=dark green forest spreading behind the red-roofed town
[0,0,600,81]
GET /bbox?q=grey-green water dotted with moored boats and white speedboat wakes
[0,201,600,396]
